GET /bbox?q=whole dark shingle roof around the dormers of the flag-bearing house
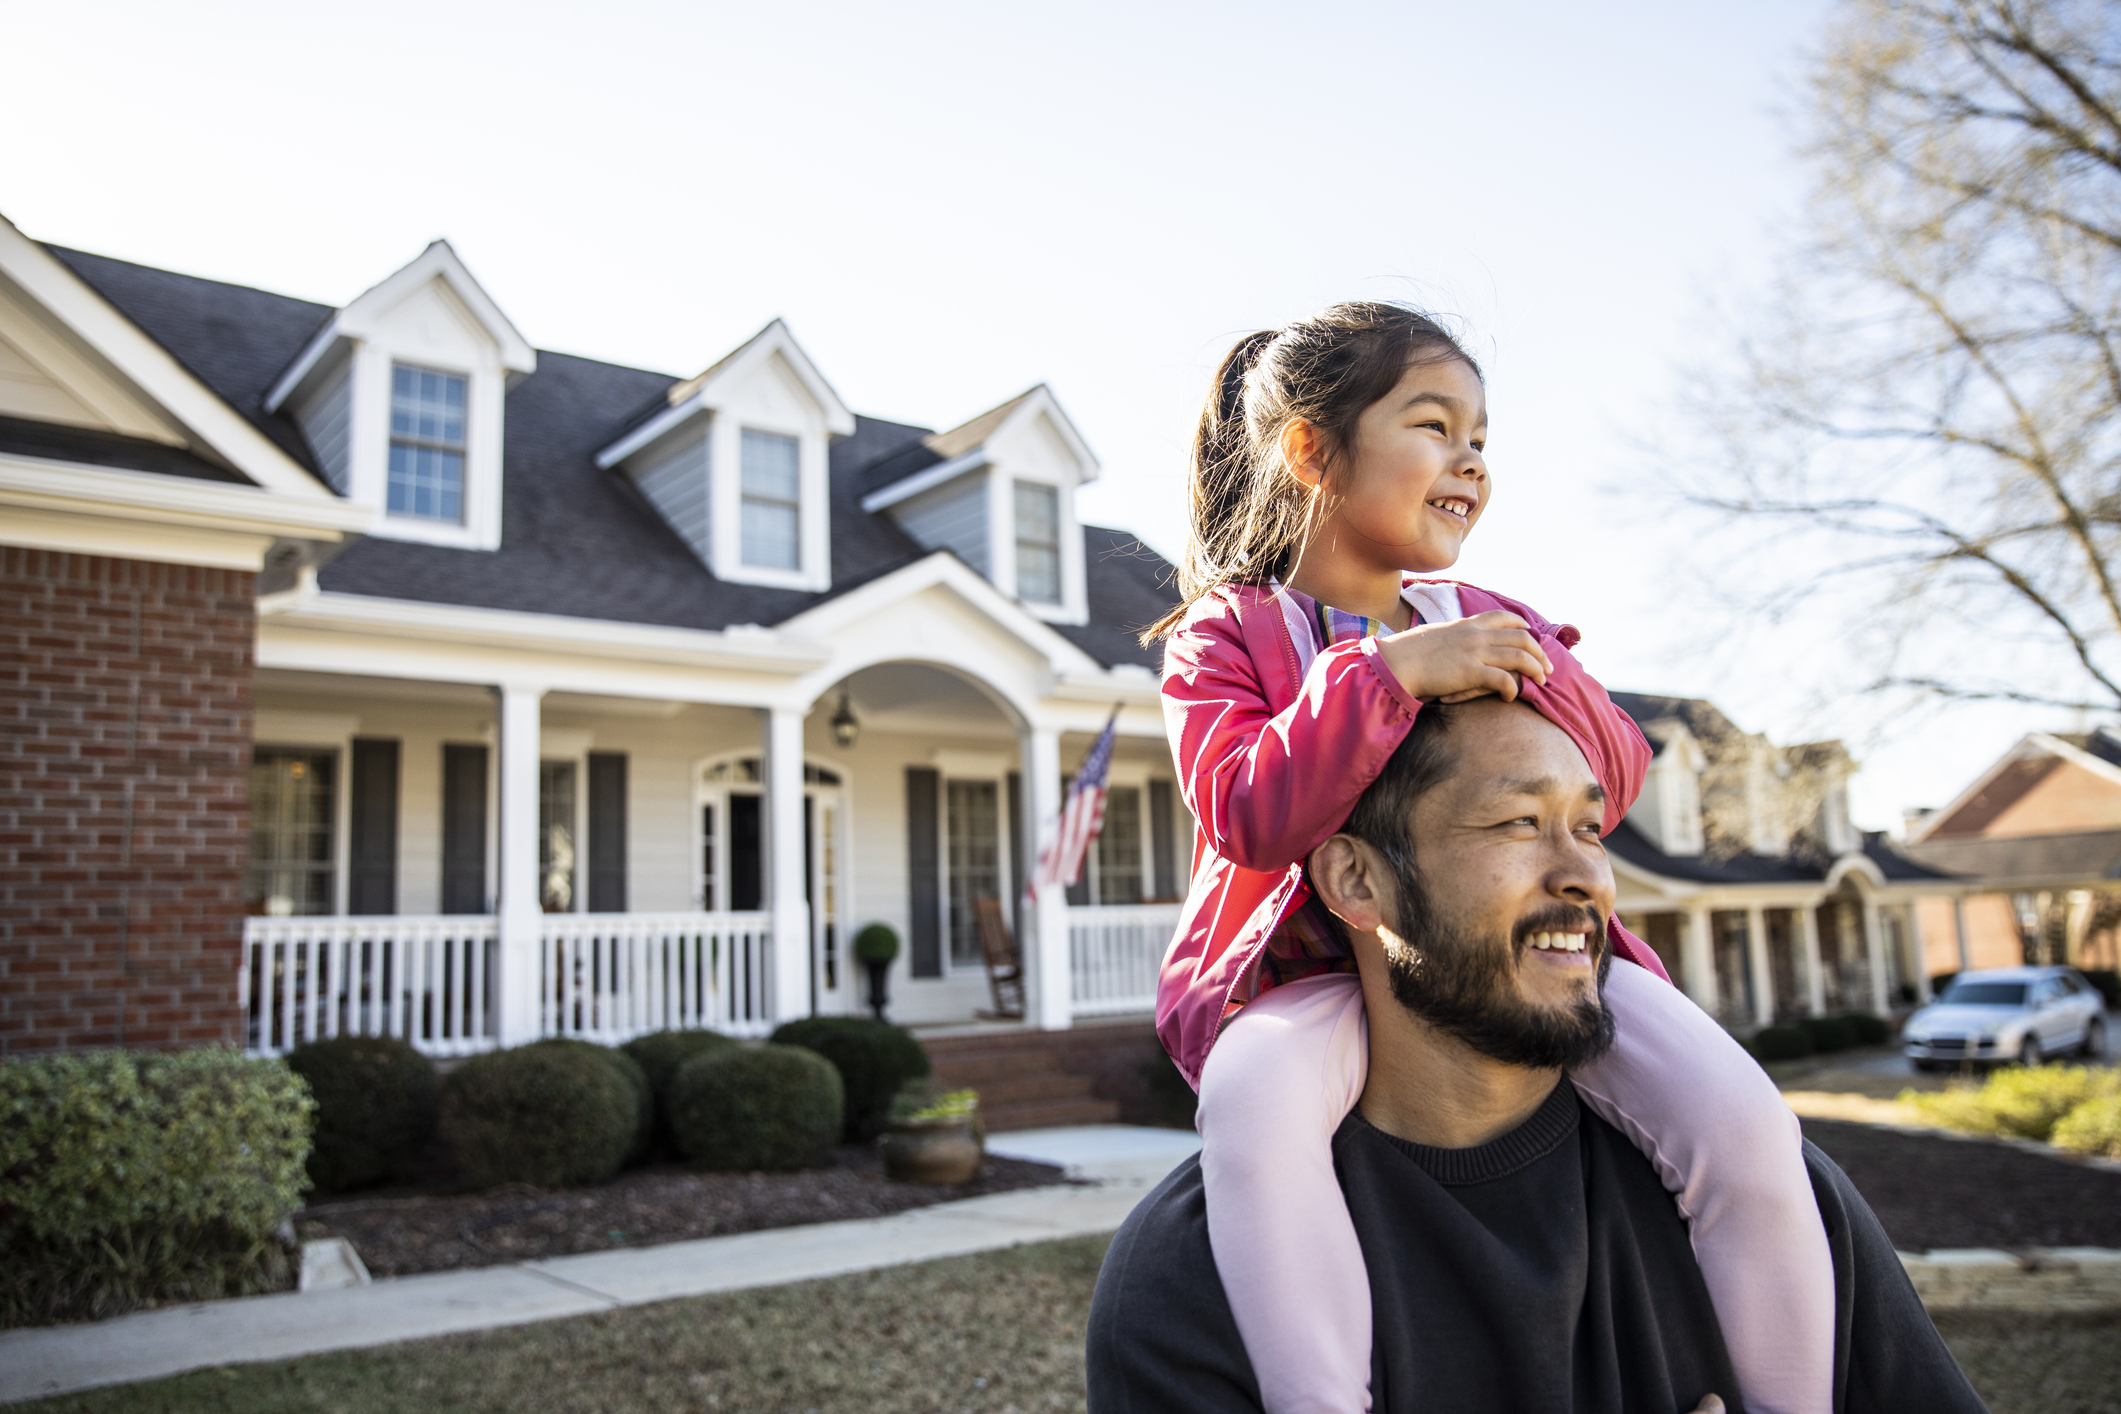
[51,246,1173,668]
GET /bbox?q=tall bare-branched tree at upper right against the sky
[1684,0,2121,712]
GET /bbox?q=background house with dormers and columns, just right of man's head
[1606,693,1958,1028]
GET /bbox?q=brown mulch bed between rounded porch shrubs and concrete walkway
[295,1145,1065,1276]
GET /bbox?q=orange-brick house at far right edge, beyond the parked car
[1907,727,2121,973]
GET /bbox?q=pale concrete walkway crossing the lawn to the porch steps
[0,1124,1200,1403]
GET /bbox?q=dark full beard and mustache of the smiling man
[1385,865,1612,1071]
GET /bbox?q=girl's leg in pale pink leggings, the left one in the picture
[1200,973,1370,1414]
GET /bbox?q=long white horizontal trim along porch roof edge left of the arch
[259,589,827,672]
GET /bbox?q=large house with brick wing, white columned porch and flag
[0,223,1192,1051]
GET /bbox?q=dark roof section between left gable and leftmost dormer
[45,246,335,473]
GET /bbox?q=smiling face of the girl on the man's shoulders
[1317,358,1489,575]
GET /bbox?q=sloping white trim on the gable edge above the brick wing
[0,216,335,500]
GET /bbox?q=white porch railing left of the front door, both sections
[242,914,772,1056]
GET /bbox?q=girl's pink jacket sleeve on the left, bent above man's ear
[1164,600,1421,871]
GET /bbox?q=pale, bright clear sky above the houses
[0,0,2079,829]
